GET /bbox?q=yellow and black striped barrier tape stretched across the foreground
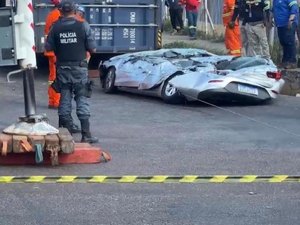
[0,175,300,184]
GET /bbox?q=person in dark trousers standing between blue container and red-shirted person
[165,0,184,35]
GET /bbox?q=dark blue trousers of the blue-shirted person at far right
[277,23,297,63]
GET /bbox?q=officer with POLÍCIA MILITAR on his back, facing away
[45,0,98,143]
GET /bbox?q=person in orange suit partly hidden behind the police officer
[44,0,61,109]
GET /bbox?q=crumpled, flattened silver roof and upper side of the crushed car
[103,48,276,89]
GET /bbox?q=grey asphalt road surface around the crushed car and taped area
[0,65,300,225]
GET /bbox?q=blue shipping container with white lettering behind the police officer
[33,0,164,54]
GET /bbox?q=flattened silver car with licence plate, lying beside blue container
[99,48,284,104]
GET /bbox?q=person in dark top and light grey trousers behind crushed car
[230,0,271,58]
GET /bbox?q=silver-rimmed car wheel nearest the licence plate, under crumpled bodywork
[161,76,185,104]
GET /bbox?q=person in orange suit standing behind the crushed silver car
[223,0,242,56]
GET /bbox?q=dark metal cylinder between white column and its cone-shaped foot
[23,68,36,117]
